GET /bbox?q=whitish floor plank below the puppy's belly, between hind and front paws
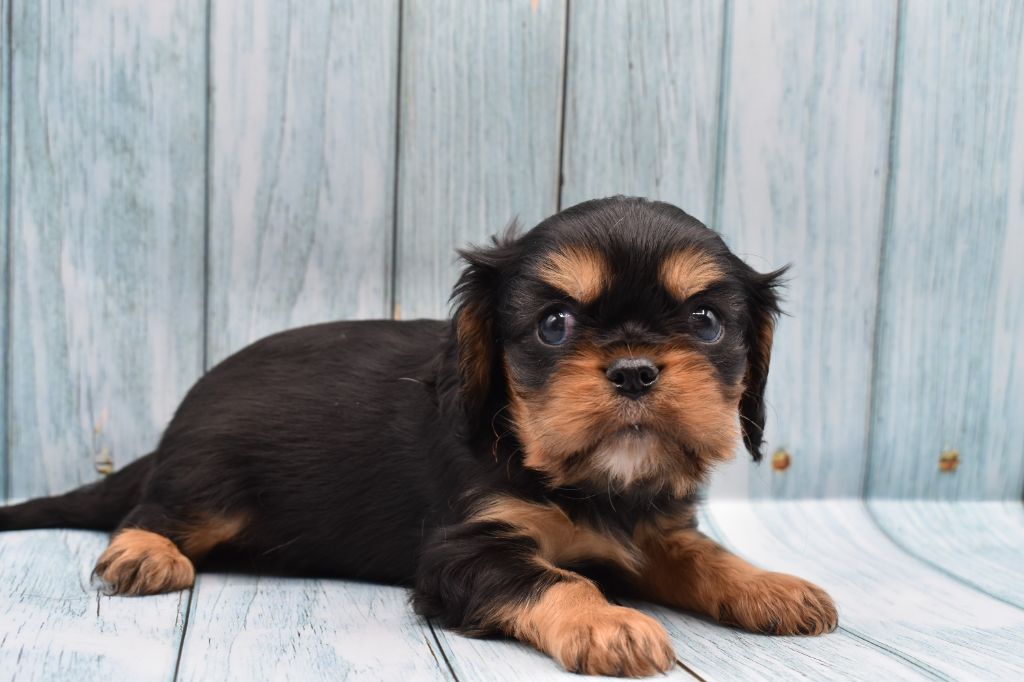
[176,574,453,682]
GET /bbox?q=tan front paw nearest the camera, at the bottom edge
[547,605,676,677]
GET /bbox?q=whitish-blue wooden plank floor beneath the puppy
[0,500,1024,682]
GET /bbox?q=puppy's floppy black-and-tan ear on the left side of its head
[452,222,519,418]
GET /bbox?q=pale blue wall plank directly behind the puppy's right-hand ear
[713,0,897,498]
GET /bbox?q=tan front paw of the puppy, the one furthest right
[718,571,839,635]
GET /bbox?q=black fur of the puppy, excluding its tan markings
[0,198,779,634]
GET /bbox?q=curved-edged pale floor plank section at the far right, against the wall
[868,500,1024,608]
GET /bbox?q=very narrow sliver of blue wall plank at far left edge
[0,0,11,499]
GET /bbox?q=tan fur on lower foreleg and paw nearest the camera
[501,578,675,677]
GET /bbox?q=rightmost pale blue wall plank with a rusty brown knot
[868,0,1024,499]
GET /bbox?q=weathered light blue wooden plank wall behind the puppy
[0,0,1024,500]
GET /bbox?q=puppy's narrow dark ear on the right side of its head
[739,265,790,462]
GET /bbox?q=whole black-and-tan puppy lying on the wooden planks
[0,197,837,676]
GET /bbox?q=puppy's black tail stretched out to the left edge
[0,454,154,530]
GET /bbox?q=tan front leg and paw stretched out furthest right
[637,526,839,635]
